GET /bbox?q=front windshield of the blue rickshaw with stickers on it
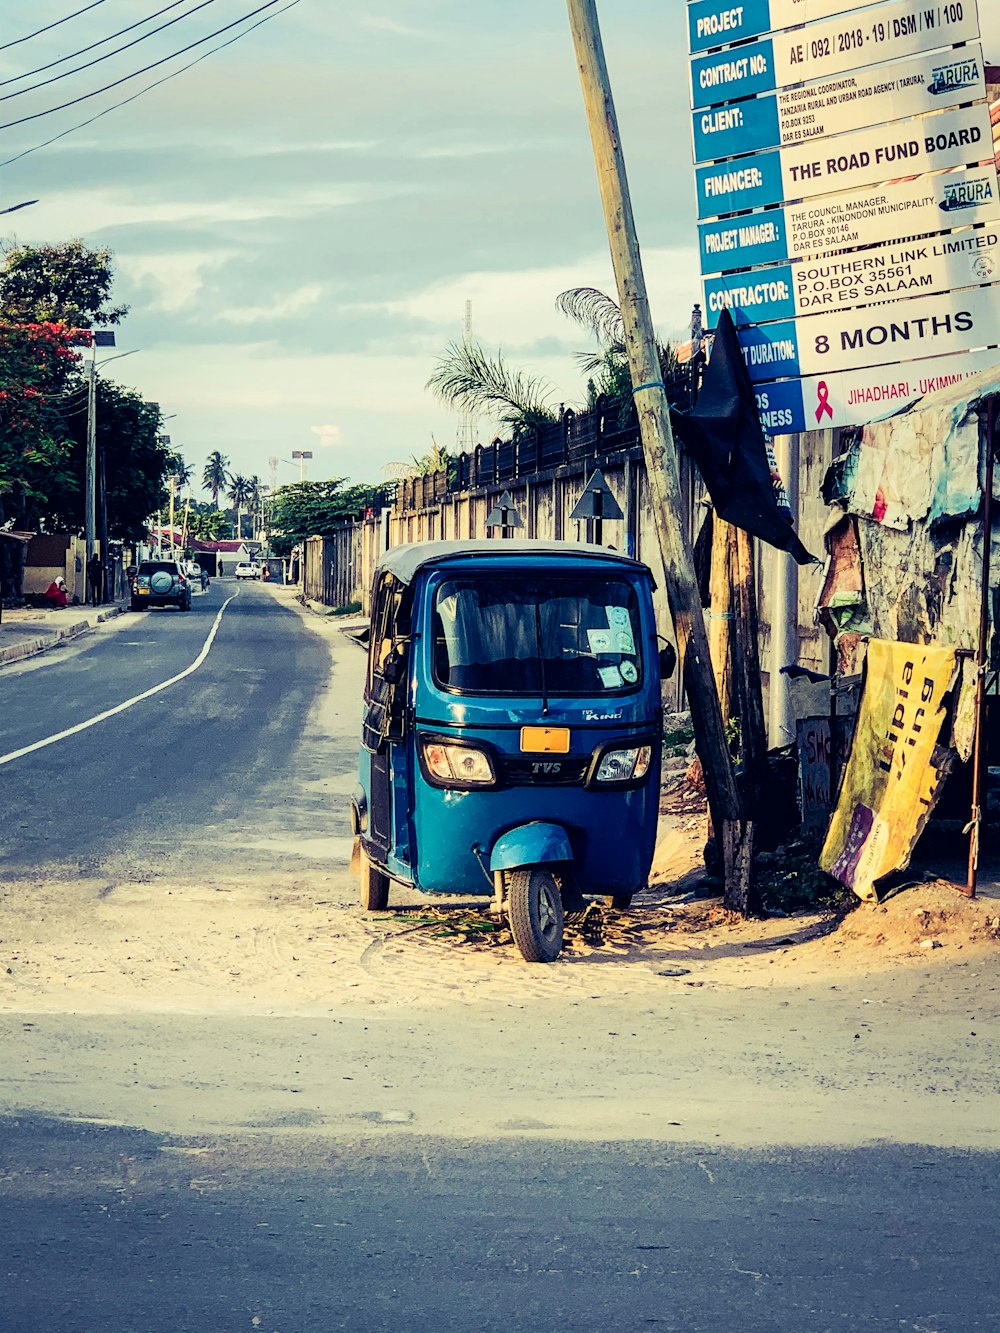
[433,575,643,696]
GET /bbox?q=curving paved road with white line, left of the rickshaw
[0,580,344,877]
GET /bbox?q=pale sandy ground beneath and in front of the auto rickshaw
[0,589,1000,1146]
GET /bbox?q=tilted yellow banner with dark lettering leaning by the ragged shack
[820,639,956,898]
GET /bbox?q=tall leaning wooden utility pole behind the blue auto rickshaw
[567,0,745,886]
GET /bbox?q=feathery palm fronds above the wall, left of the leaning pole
[427,341,556,437]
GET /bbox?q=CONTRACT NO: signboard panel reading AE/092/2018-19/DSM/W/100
[691,0,979,108]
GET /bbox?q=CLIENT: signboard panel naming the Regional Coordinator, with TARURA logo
[692,44,987,163]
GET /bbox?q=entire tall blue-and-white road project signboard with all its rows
[688,0,1000,435]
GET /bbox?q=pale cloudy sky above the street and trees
[0,0,1000,495]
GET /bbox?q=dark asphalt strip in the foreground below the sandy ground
[0,1121,1000,1333]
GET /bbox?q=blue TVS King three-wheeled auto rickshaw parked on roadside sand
[352,540,675,962]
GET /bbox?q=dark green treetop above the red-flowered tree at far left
[0,240,128,329]
